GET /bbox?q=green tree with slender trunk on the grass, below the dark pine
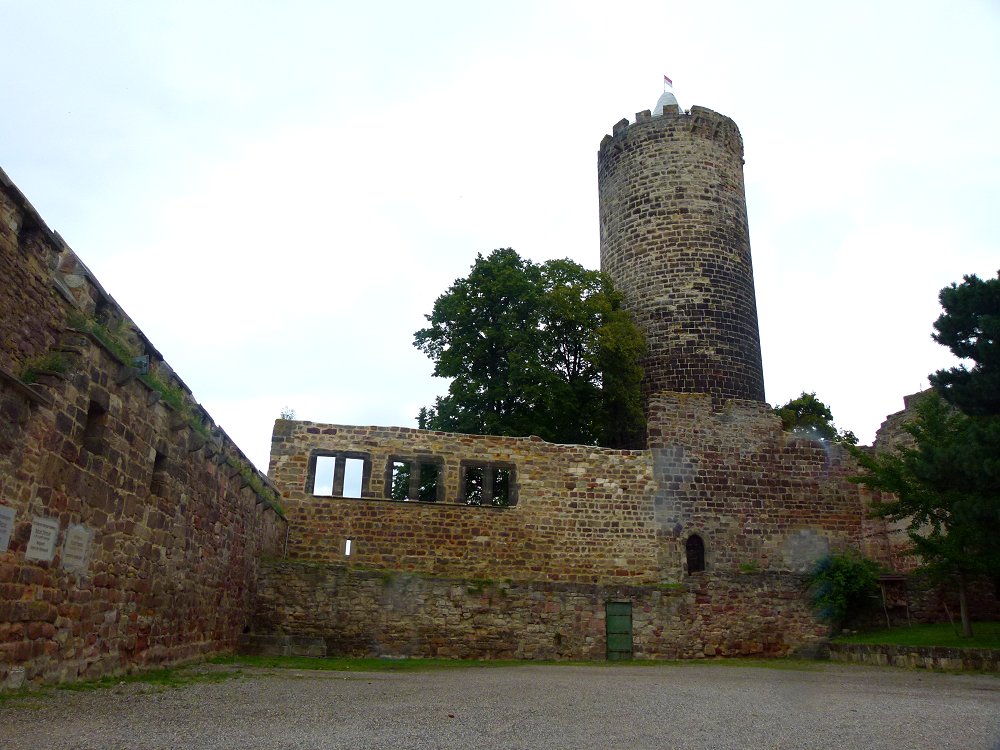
[852,391,1000,637]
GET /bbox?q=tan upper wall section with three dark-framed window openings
[269,420,660,583]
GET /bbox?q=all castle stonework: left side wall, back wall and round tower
[0,92,995,676]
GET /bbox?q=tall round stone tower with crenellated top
[597,102,764,403]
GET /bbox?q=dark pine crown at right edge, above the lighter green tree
[930,272,1000,416]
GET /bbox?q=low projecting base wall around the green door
[246,561,826,660]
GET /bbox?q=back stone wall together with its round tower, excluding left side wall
[245,101,980,659]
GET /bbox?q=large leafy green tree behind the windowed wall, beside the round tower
[414,248,644,447]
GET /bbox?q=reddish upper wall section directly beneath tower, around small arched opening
[649,393,904,572]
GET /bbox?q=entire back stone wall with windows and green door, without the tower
[252,393,901,659]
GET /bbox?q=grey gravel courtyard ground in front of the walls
[0,665,1000,750]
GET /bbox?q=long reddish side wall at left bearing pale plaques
[0,167,285,687]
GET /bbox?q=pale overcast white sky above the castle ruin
[0,0,1000,469]
